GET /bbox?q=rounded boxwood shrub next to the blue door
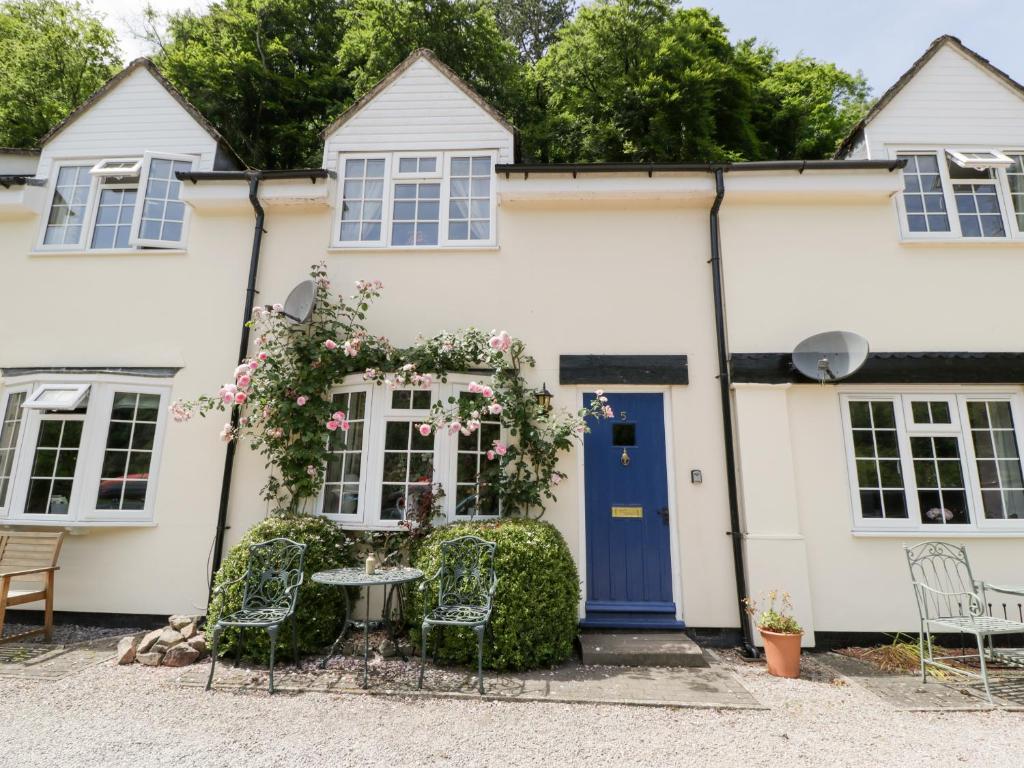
[408,518,580,670]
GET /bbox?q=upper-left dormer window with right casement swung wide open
[39,153,196,251]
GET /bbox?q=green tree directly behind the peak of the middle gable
[338,0,523,124]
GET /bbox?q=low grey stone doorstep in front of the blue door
[580,632,708,667]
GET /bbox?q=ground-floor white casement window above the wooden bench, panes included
[0,377,170,526]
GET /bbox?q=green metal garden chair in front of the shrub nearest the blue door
[418,536,498,693]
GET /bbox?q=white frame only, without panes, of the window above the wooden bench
[0,375,171,527]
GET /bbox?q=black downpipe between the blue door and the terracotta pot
[711,168,758,657]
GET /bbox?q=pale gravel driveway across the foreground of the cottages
[0,664,1024,768]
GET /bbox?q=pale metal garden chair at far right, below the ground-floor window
[903,542,1024,703]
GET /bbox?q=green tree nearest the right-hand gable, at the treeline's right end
[739,41,870,160]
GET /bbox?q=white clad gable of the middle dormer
[324,54,513,169]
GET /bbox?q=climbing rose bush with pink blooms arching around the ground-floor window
[170,263,612,516]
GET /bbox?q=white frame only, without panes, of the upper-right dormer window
[887,144,1024,244]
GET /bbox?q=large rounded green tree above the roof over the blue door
[528,0,759,162]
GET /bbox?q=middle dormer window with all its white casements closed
[335,151,496,248]
